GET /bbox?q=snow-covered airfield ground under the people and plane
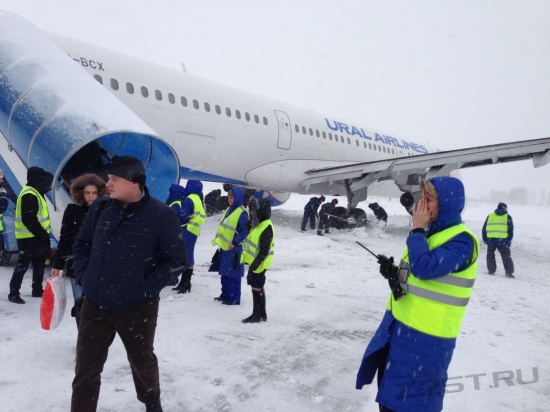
[0,185,550,412]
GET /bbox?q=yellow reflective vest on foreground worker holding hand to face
[387,223,479,338]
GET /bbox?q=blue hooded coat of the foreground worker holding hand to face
[356,177,474,412]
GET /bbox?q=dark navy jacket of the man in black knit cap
[73,188,187,310]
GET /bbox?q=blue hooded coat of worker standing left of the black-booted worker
[208,186,248,278]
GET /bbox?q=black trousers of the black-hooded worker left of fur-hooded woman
[9,238,50,296]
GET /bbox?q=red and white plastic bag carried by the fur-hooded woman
[40,276,67,330]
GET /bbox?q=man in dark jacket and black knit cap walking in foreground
[71,156,187,412]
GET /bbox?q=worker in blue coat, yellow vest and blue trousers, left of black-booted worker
[209,186,248,305]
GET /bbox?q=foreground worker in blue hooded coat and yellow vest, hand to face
[356,176,479,412]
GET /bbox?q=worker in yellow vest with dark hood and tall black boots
[242,198,275,323]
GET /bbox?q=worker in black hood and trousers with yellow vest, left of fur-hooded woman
[8,166,53,304]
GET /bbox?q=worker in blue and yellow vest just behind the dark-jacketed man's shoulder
[167,180,206,293]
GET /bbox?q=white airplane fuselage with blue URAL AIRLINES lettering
[48,34,435,194]
